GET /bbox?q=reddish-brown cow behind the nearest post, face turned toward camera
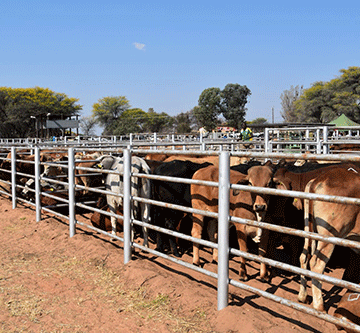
[190,163,275,280]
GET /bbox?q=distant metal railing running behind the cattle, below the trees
[0,125,360,154]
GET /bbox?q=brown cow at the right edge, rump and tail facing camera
[298,167,360,311]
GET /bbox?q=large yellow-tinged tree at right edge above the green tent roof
[294,67,360,123]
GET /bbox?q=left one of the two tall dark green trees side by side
[194,88,222,131]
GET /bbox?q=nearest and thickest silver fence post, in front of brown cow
[217,152,230,310]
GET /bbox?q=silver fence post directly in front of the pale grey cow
[123,149,132,264]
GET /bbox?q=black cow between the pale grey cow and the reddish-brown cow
[152,160,210,257]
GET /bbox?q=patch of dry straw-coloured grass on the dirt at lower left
[0,253,209,333]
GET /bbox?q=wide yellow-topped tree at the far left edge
[0,87,82,137]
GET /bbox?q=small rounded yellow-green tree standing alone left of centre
[92,96,130,135]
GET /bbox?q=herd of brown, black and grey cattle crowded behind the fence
[0,146,360,322]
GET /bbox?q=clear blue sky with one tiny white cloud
[0,0,360,134]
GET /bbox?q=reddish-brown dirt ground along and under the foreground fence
[0,197,345,333]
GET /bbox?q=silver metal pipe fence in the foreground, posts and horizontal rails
[0,146,360,332]
